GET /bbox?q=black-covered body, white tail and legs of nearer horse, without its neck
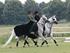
[3,21,39,47]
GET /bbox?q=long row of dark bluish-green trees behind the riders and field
[0,0,70,24]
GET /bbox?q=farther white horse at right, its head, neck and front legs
[42,15,58,46]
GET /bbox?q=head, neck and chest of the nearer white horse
[37,15,48,40]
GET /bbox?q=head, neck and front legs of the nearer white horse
[29,15,48,46]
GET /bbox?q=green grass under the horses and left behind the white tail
[0,25,70,53]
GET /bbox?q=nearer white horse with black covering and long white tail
[3,15,47,47]
